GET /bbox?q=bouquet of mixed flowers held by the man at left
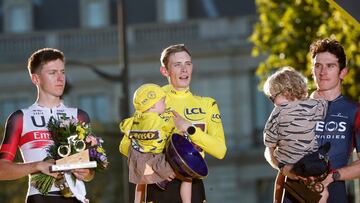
[31,118,108,197]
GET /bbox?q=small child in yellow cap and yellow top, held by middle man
[120,84,191,203]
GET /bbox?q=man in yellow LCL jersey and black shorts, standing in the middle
[146,44,226,203]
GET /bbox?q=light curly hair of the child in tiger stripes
[263,66,308,101]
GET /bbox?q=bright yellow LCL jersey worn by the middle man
[119,85,226,159]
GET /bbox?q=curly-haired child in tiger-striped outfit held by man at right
[264,67,328,202]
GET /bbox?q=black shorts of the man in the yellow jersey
[146,179,206,203]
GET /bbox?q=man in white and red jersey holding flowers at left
[0,48,94,203]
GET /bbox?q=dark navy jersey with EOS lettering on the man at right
[315,95,360,203]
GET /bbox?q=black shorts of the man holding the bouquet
[25,192,81,203]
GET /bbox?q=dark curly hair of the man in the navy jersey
[310,38,346,70]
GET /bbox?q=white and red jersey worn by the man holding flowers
[0,103,89,195]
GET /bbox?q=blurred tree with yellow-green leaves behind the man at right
[250,0,360,101]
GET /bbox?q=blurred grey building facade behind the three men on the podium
[0,0,354,203]
